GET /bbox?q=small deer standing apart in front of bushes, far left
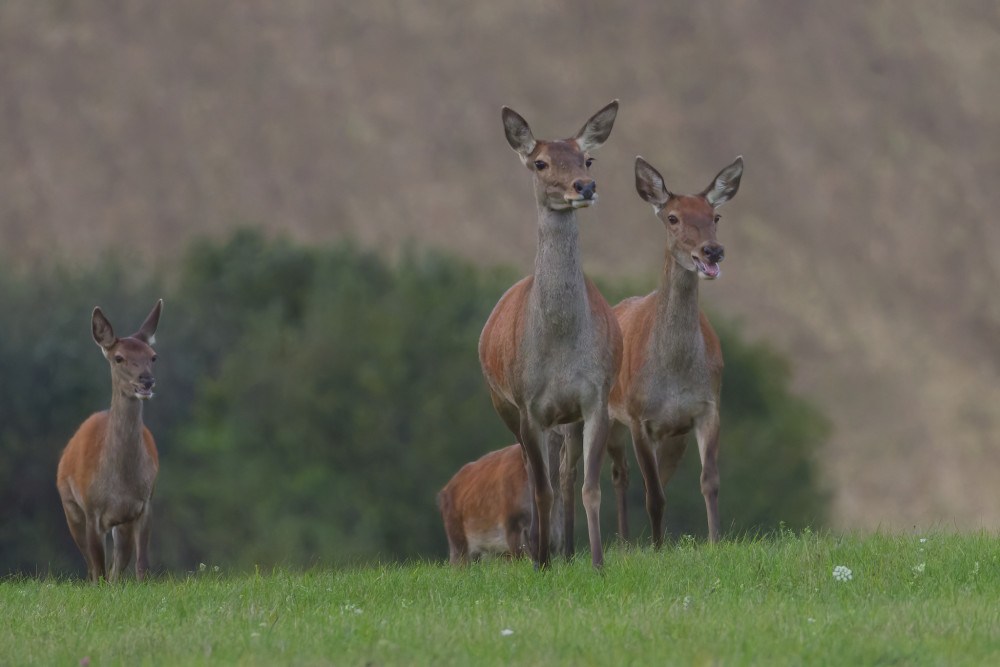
[56,299,163,583]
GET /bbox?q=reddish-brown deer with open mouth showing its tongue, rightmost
[609,157,743,547]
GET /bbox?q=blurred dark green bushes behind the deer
[0,230,828,574]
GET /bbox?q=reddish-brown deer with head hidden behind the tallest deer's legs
[437,444,563,565]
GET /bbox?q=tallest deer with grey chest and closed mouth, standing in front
[479,100,622,569]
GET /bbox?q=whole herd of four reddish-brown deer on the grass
[57,100,743,582]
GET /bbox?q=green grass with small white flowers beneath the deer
[0,532,1000,666]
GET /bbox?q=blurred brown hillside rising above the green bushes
[0,0,1000,528]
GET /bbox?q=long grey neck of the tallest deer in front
[530,208,589,335]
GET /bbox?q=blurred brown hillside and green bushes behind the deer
[0,0,1000,572]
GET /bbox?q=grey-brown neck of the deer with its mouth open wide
[652,250,705,370]
